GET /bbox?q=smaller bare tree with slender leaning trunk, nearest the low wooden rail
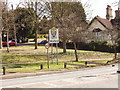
[67,13,86,61]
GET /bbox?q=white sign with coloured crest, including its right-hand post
[49,27,59,64]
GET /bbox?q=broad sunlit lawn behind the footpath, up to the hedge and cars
[2,46,114,64]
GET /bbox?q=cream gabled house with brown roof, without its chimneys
[87,16,113,41]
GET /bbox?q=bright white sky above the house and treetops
[8,0,119,19]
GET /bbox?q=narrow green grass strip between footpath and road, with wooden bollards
[0,60,114,73]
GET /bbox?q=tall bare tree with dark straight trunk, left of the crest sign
[21,0,49,49]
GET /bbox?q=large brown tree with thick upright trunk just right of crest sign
[51,2,86,53]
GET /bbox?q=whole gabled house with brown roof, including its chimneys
[87,5,120,42]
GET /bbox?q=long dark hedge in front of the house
[59,41,120,53]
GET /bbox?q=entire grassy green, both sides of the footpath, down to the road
[0,45,114,73]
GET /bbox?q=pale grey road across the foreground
[1,65,118,88]
